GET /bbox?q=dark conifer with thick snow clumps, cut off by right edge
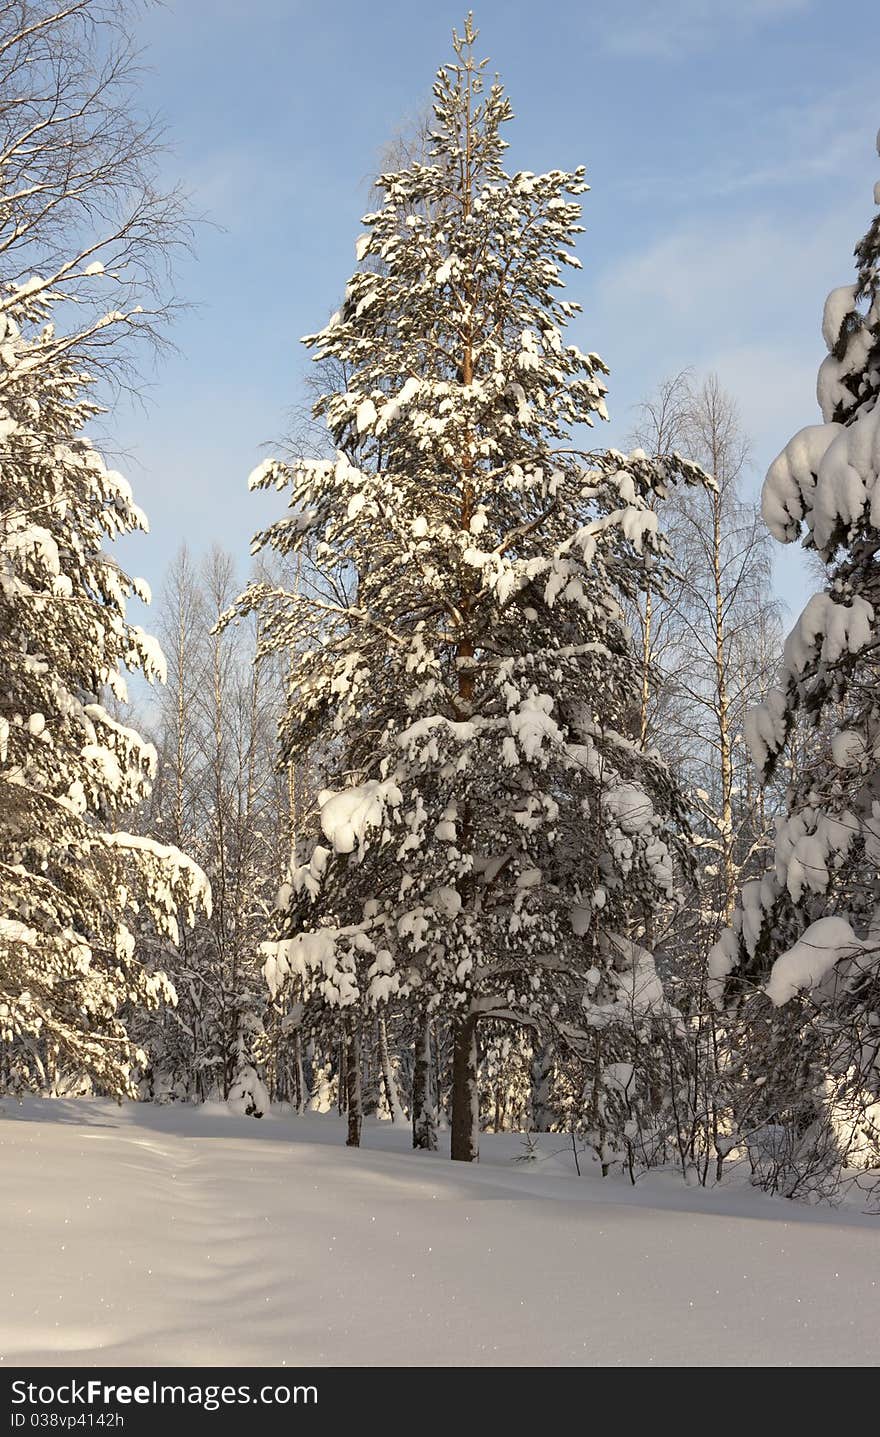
[712,137,880,1172]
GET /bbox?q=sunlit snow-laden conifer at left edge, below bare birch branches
[0,286,210,1094]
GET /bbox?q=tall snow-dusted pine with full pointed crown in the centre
[240,19,702,1160]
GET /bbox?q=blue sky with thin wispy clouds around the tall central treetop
[111,0,880,609]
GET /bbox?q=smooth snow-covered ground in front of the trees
[0,1099,880,1367]
